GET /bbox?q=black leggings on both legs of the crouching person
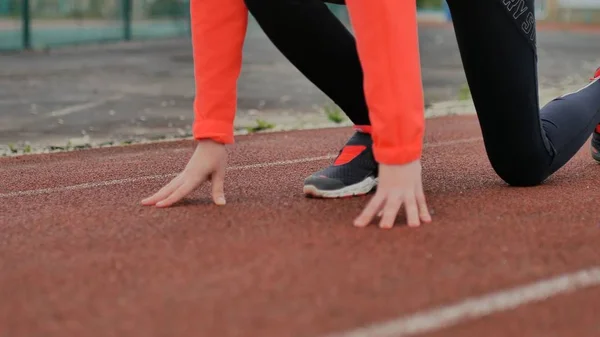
[245,0,600,186]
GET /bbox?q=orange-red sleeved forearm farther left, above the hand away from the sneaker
[190,0,248,143]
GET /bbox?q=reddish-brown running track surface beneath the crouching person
[0,116,600,337]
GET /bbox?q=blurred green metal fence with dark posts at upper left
[0,0,189,50]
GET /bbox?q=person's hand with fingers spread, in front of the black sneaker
[354,160,431,228]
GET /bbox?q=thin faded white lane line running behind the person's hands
[0,137,481,199]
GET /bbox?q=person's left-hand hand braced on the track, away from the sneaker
[142,140,227,207]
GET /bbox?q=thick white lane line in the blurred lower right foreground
[327,266,600,337]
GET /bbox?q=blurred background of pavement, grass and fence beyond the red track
[0,0,600,155]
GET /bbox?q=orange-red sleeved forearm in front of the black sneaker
[346,0,425,164]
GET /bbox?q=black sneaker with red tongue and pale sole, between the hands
[303,131,378,198]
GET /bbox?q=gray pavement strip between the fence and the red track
[0,18,600,154]
